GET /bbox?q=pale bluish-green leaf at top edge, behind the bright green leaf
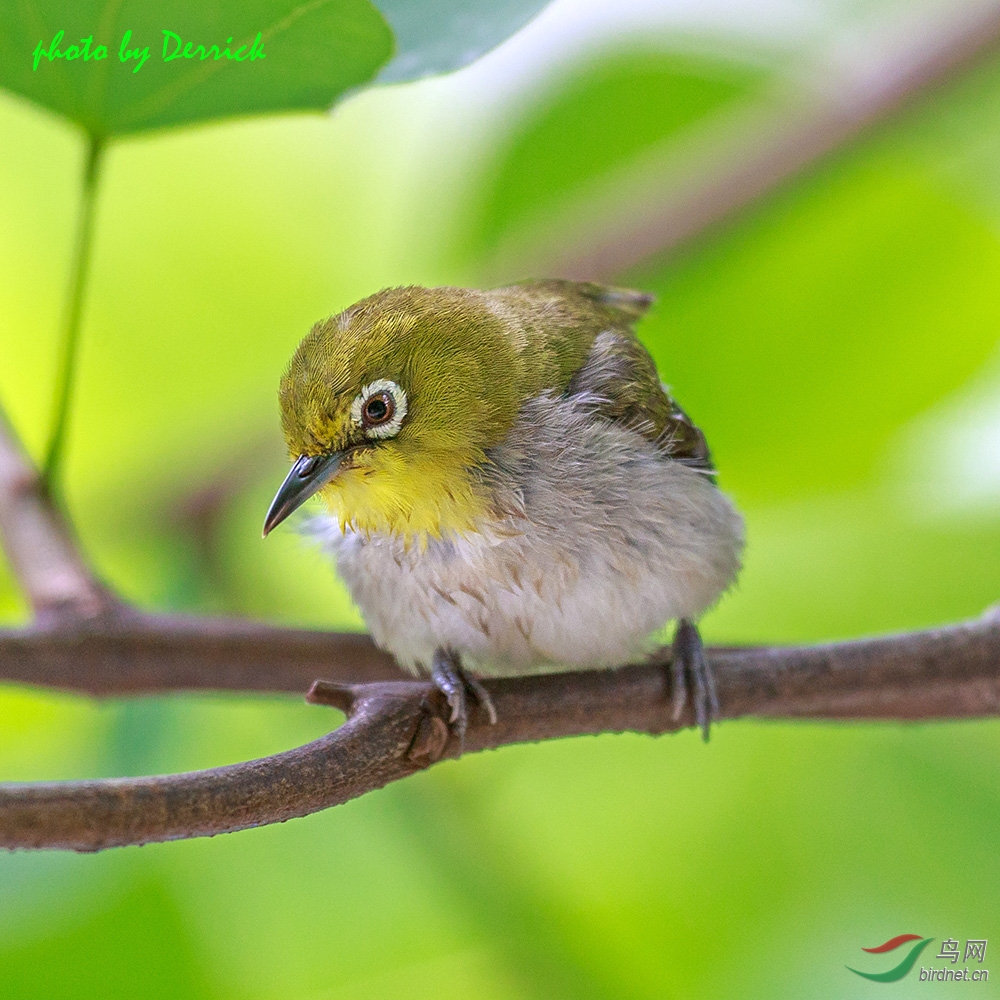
[377,0,548,83]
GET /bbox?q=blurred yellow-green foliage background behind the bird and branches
[0,0,1000,1000]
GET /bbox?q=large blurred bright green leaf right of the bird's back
[636,157,1000,502]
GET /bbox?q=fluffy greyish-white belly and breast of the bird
[316,399,743,674]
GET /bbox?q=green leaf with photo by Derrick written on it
[0,0,392,139]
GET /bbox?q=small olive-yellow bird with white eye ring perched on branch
[263,279,744,740]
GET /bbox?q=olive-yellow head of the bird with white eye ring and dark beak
[264,288,524,538]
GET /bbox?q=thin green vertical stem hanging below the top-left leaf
[42,136,104,494]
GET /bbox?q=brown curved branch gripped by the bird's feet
[0,610,1000,851]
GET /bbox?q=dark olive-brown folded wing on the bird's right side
[566,324,715,475]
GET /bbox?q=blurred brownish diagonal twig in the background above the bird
[500,2,1000,281]
